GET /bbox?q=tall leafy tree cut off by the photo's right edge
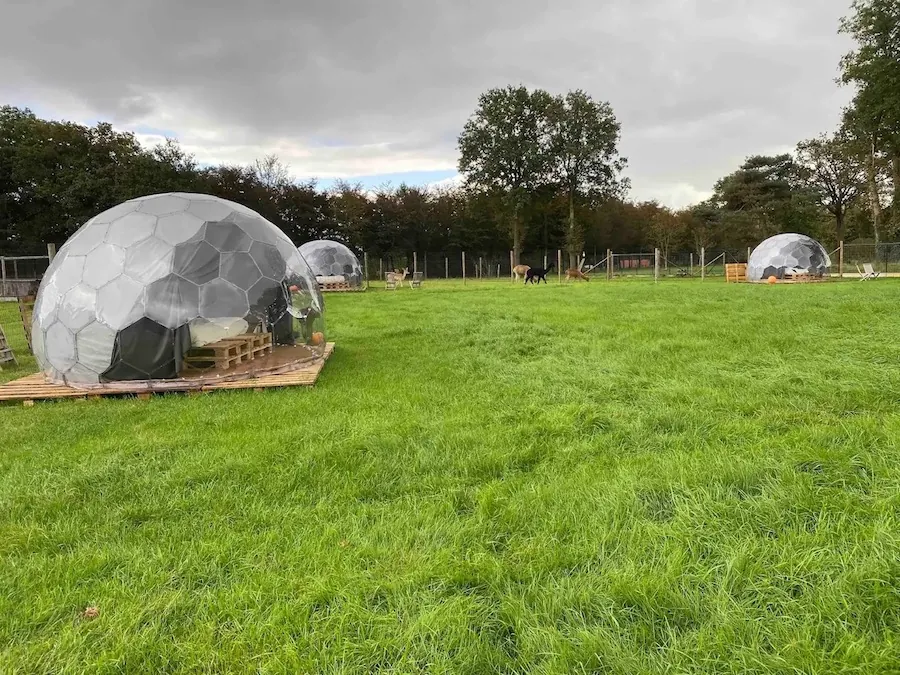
[840,0,900,232]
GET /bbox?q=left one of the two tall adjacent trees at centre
[459,86,552,263]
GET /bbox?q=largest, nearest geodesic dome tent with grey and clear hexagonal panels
[32,192,325,387]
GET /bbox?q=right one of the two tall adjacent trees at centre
[548,89,627,267]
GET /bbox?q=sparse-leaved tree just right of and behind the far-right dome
[797,132,865,241]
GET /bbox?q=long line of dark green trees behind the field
[0,0,900,264]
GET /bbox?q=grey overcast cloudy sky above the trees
[0,0,850,207]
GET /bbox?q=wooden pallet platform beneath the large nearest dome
[0,342,334,407]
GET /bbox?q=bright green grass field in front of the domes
[0,280,900,673]
